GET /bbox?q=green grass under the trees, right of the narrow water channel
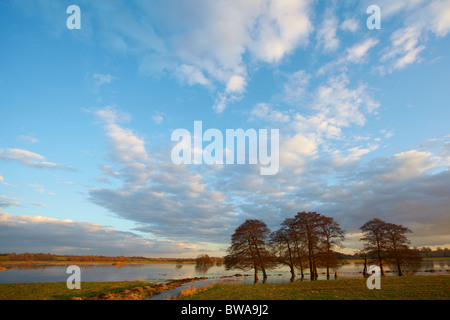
[179,276,450,300]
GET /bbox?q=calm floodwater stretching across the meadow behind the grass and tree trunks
[0,259,450,283]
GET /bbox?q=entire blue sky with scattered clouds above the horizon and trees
[0,0,450,256]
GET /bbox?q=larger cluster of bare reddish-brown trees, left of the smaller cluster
[225,212,344,281]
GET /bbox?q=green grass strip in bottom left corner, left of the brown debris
[0,281,150,300]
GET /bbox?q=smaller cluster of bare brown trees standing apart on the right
[360,218,421,276]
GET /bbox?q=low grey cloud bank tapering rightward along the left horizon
[0,212,197,256]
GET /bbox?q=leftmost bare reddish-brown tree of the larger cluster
[225,220,275,282]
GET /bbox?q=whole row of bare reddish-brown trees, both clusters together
[224,212,420,282]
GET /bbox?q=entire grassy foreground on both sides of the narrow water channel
[0,276,450,300]
